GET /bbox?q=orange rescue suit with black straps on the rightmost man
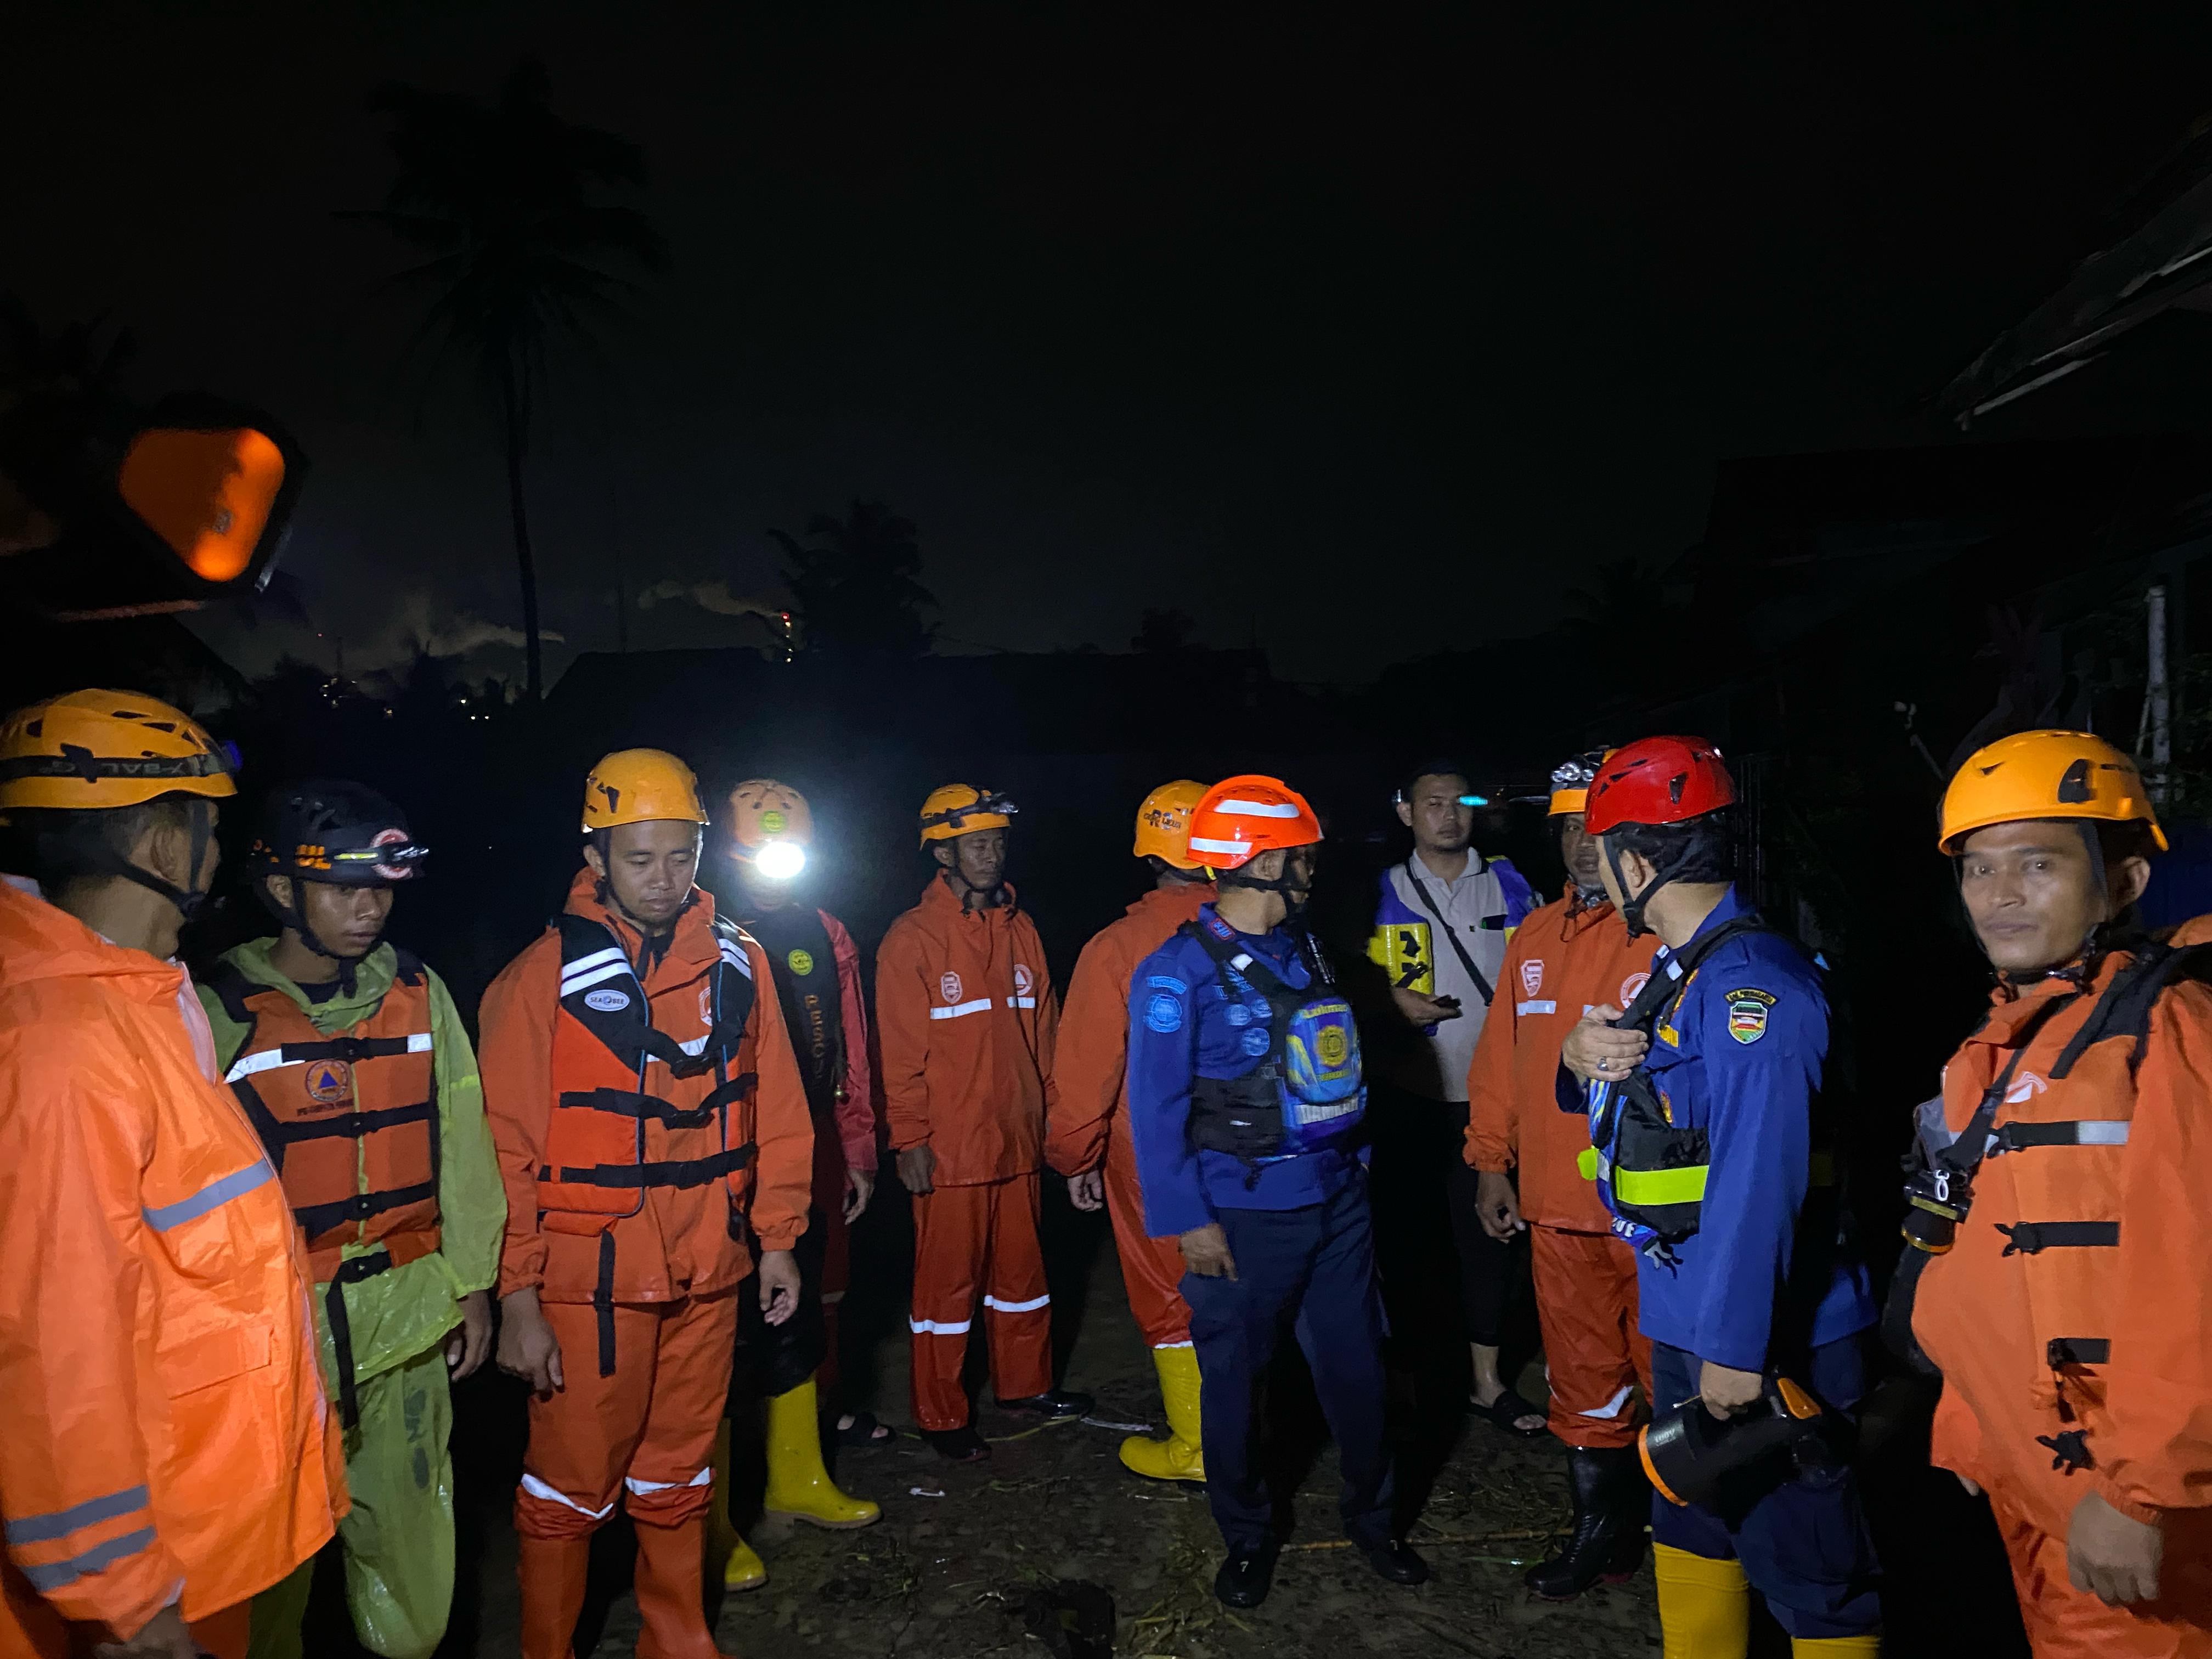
[1914,951,2212,1659]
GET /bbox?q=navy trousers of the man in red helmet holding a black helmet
[1652,1331,1882,1639]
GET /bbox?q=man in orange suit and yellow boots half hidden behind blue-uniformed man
[1044,778,1215,1480]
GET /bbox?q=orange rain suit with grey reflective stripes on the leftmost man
[0,883,345,1659]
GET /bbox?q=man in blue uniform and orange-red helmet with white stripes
[1128,776,1429,1608]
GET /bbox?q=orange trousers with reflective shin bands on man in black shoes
[907,1175,1053,1429]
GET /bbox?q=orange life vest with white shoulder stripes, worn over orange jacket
[538,913,754,1234]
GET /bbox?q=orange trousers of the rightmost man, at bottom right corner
[1989,1493,2212,1659]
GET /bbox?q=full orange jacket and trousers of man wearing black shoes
[876,878,1059,1429]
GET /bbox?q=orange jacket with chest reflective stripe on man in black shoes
[876,878,1059,1186]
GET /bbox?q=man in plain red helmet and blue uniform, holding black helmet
[1562,737,1880,1659]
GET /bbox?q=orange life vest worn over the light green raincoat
[210,951,438,1283]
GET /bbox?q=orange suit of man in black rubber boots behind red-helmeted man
[1466,894,1659,1451]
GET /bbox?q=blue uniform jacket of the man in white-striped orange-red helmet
[1128,905,1354,1239]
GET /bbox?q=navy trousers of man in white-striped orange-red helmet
[1181,1170,1391,1550]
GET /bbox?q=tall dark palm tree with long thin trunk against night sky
[343,60,668,699]
